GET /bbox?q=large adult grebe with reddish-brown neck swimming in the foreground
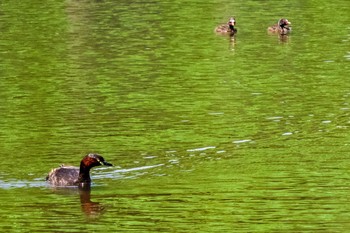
[46,154,113,186]
